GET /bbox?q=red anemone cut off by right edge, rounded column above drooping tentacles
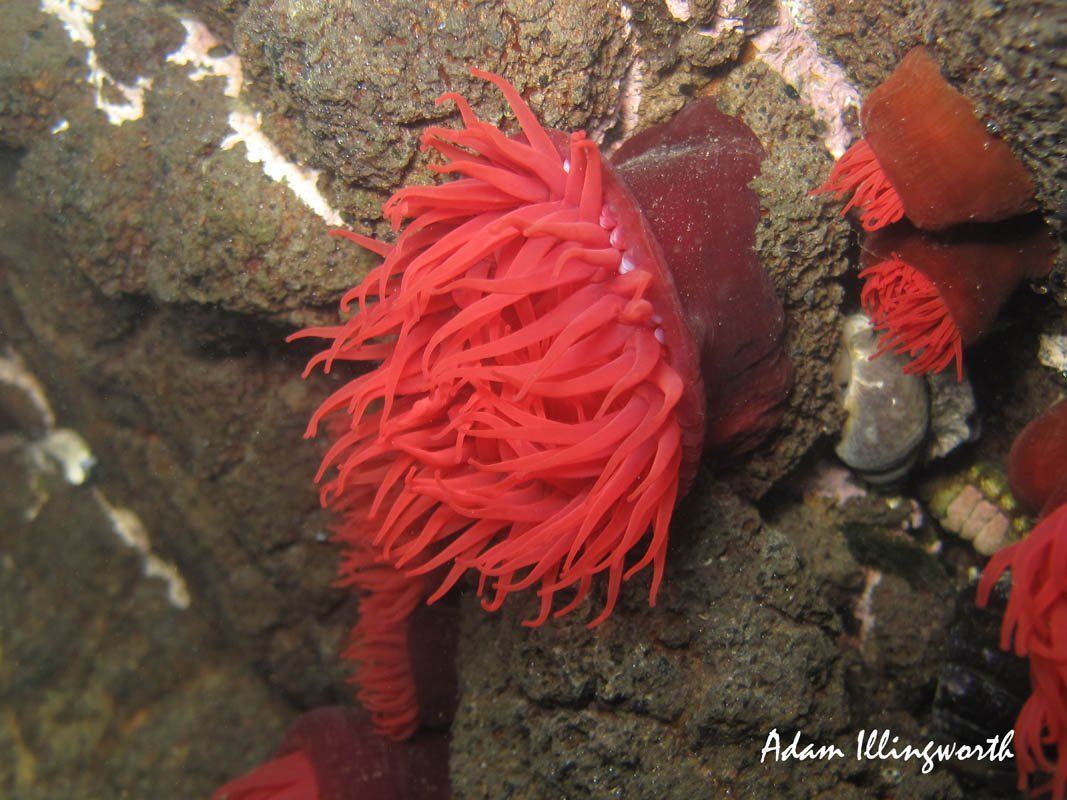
[977,400,1067,800]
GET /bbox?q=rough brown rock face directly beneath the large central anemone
[452,476,964,799]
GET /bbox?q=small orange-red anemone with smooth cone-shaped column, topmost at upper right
[816,47,1035,230]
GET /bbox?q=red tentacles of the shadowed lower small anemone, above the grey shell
[860,254,964,381]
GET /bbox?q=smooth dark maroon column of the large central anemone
[611,99,793,462]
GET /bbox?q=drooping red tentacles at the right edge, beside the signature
[977,505,1067,800]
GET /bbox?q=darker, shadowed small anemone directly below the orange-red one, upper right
[860,218,1052,380]
